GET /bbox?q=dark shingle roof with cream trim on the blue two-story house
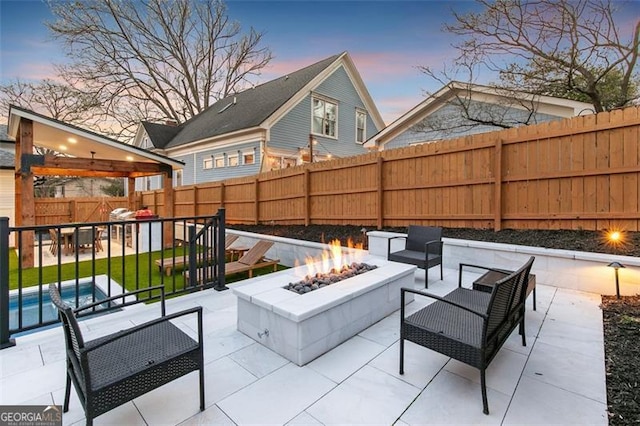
[141,52,384,149]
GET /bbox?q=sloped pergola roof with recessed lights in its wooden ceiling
[7,105,184,177]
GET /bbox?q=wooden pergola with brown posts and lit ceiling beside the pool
[8,105,184,267]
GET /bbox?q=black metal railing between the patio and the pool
[0,209,226,349]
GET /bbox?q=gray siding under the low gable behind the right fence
[384,101,562,149]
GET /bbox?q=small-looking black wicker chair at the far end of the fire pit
[387,225,442,288]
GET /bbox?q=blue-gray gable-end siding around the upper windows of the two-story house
[269,67,378,157]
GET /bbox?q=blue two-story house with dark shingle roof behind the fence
[133,52,384,190]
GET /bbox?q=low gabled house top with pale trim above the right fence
[365,81,594,151]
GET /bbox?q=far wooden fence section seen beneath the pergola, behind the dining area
[35,197,128,225]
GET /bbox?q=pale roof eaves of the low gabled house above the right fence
[364,81,595,149]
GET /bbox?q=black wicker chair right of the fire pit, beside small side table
[400,257,534,414]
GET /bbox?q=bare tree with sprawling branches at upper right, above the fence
[421,0,640,127]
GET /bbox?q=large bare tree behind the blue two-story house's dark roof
[48,0,271,128]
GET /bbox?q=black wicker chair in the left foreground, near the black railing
[49,284,204,425]
